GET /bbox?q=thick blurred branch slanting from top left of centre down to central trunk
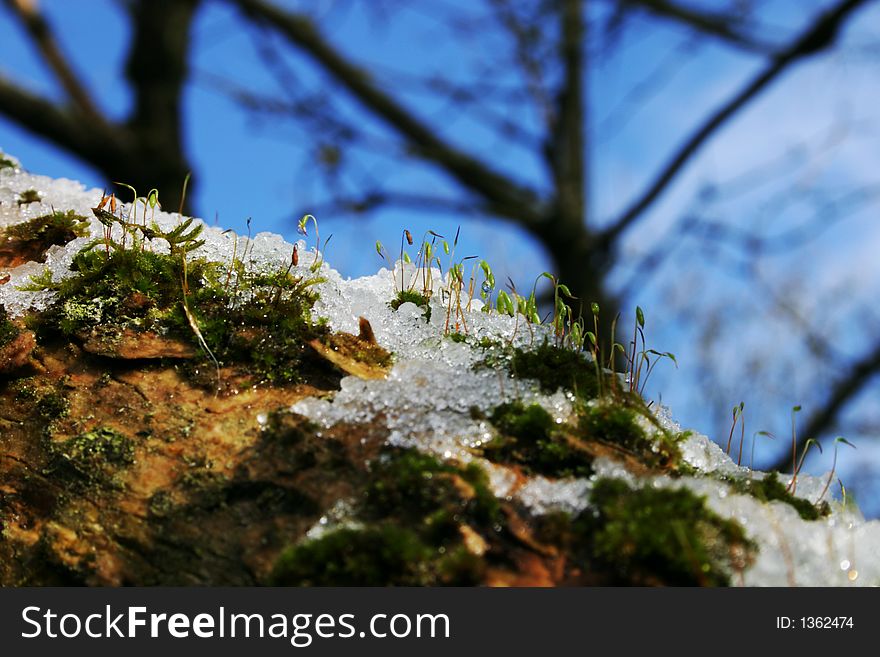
[232,0,544,227]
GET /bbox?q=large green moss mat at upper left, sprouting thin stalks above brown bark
[31,244,328,383]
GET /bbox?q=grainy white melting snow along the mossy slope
[0,151,880,586]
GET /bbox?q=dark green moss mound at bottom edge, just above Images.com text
[271,524,482,586]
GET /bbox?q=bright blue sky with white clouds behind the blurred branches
[0,0,880,512]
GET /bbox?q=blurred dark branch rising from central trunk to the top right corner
[601,0,870,244]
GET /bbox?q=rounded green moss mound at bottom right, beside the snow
[542,478,756,586]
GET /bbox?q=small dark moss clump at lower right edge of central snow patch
[482,402,593,477]
